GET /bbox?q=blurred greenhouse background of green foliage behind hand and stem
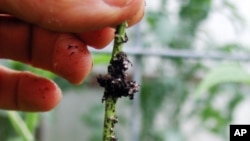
[0,0,250,141]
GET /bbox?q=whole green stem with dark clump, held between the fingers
[97,22,139,141]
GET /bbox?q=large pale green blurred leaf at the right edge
[195,64,250,95]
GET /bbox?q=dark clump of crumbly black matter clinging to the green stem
[97,52,139,102]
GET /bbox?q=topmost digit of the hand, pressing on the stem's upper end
[0,0,144,33]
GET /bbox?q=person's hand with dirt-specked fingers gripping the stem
[0,0,144,112]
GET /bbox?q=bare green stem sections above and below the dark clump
[103,22,127,141]
